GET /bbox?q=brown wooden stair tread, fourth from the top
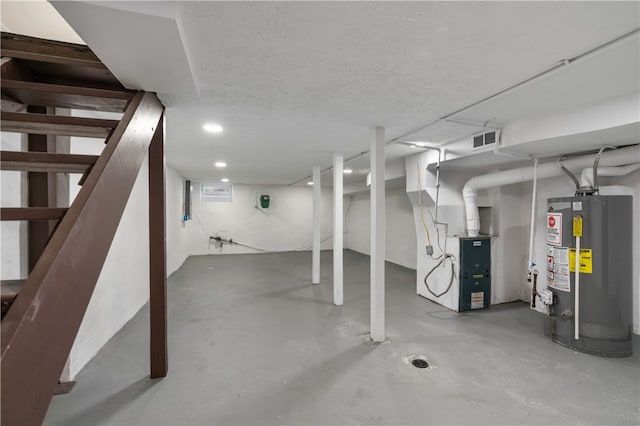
[0,151,99,173]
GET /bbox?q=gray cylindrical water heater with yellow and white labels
[547,195,634,357]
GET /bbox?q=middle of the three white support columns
[333,154,344,306]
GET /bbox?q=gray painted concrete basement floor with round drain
[45,252,640,425]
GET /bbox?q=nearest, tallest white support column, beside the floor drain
[370,127,386,342]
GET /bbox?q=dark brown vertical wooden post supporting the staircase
[149,115,168,379]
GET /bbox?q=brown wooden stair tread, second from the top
[2,80,135,112]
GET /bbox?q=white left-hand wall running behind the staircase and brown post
[64,131,187,380]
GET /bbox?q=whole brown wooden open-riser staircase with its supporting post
[0,33,167,426]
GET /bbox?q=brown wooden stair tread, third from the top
[0,111,119,138]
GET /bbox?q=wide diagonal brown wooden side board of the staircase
[0,92,163,426]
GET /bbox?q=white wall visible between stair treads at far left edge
[0,132,27,280]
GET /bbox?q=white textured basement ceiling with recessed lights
[54,2,640,184]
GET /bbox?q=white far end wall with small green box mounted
[186,182,336,255]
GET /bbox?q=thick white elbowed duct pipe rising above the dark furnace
[462,145,640,237]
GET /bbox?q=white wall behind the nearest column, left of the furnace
[345,189,416,269]
